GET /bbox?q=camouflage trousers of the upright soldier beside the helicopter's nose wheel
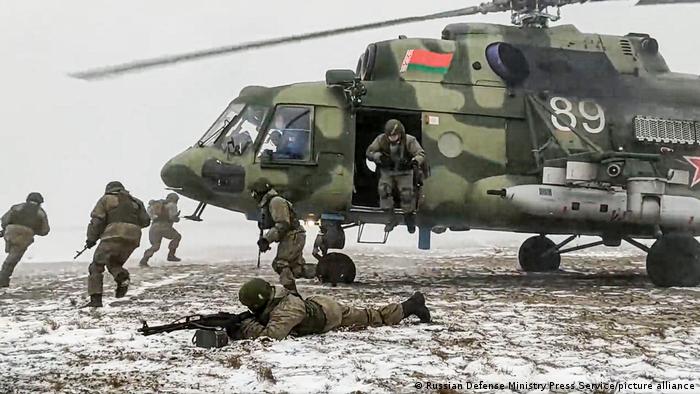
[272,230,313,290]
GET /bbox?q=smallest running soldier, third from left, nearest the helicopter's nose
[139,193,182,267]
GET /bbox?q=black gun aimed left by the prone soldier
[136,311,253,337]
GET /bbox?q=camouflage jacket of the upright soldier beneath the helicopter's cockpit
[260,189,306,242]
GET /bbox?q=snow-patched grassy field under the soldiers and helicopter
[0,248,700,393]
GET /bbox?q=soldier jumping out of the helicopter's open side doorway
[366,119,425,233]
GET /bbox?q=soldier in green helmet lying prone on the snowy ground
[234,278,430,339]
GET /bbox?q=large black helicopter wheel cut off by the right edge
[647,234,700,287]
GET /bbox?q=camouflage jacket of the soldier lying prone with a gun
[238,286,326,339]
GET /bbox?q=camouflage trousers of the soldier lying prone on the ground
[307,296,403,332]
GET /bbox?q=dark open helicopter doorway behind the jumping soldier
[352,108,422,208]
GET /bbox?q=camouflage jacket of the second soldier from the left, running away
[87,191,151,245]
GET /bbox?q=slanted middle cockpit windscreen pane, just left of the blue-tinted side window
[218,104,268,155]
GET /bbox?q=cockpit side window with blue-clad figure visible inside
[258,105,313,161]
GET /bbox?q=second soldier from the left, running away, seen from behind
[85,181,151,307]
